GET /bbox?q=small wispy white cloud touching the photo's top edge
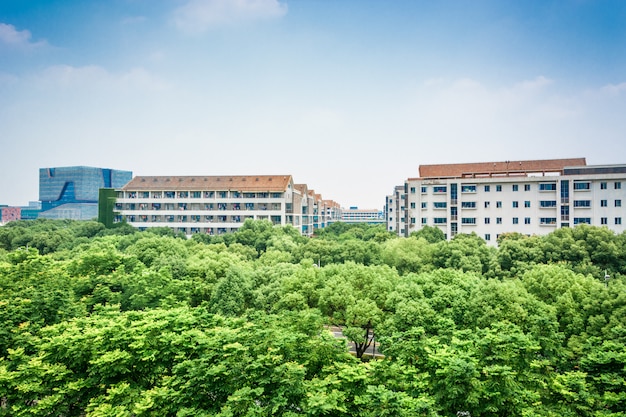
[173,0,287,33]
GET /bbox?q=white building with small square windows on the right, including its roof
[387,158,626,245]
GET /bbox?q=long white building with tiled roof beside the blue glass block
[115,175,332,236]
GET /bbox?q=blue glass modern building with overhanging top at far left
[38,166,133,220]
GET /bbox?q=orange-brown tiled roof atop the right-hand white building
[419,158,587,178]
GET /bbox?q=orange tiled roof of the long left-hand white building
[122,175,291,192]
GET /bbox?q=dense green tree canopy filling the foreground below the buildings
[0,221,626,417]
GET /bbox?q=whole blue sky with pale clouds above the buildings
[0,0,626,209]
